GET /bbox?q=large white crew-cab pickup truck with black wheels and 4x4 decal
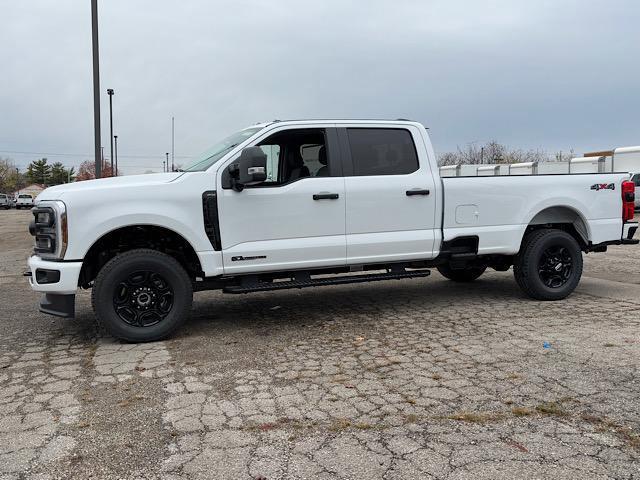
[26,120,638,341]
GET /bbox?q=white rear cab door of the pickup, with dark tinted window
[338,124,436,265]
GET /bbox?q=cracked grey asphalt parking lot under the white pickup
[0,210,640,480]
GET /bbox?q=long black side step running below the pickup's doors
[222,270,431,293]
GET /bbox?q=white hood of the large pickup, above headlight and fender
[36,172,184,201]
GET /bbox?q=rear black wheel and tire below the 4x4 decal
[513,229,582,300]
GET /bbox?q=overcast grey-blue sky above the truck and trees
[0,0,640,173]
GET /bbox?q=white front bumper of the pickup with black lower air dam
[27,255,82,318]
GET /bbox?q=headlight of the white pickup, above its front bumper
[29,201,68,259]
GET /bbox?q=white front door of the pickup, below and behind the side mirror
[218,127,346,274]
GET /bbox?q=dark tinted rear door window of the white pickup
[347,128,418,176]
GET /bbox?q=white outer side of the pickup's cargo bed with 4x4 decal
[442,173,628,254]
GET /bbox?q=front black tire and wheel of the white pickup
[91,249,193,342]
